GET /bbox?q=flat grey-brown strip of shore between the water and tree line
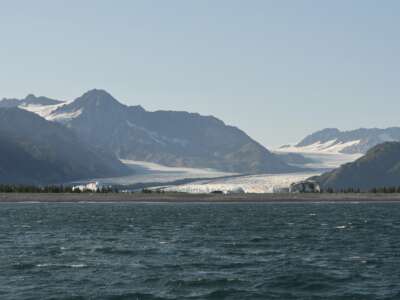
[0,193,400,202]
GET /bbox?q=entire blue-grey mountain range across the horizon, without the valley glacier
[0,89,400,190]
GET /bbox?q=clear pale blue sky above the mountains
[0,0,400,148]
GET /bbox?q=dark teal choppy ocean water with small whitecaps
[0,203,400,300]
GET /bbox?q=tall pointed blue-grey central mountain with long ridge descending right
[48,90,297,173]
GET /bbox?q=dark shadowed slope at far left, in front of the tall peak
[0,108,130,184]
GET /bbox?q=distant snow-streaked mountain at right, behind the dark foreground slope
[293,127,400,154]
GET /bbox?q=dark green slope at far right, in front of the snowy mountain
[315,142,400,190]
